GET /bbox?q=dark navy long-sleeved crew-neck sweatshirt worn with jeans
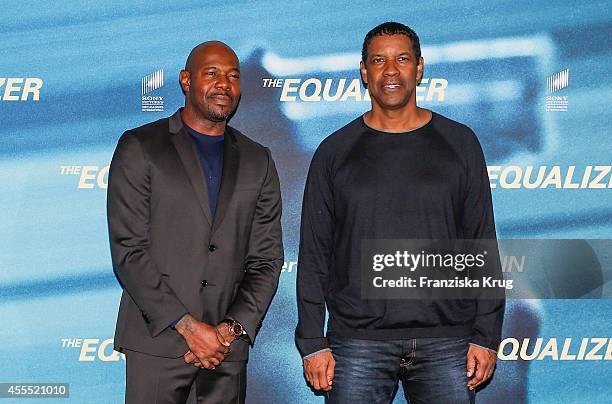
[296,113,505,356]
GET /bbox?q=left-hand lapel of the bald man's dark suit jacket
[169,110,214,225]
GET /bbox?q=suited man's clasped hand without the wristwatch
[174,314,229,369]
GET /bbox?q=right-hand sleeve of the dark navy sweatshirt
[462,131,505,351]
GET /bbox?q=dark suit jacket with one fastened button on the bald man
[107,110,283,360]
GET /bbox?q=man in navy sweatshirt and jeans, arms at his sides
[296,22,505,404]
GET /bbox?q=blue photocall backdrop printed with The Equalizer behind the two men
[0,0,612,403]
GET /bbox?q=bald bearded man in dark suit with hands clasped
[107,41,283,403]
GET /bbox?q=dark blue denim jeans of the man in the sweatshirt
[327,333,475,404]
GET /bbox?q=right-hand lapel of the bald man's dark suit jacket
[212,127,240,232]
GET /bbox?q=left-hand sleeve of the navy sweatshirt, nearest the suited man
[295,147,334,357]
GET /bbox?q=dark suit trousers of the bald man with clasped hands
[124,350,246,404]
